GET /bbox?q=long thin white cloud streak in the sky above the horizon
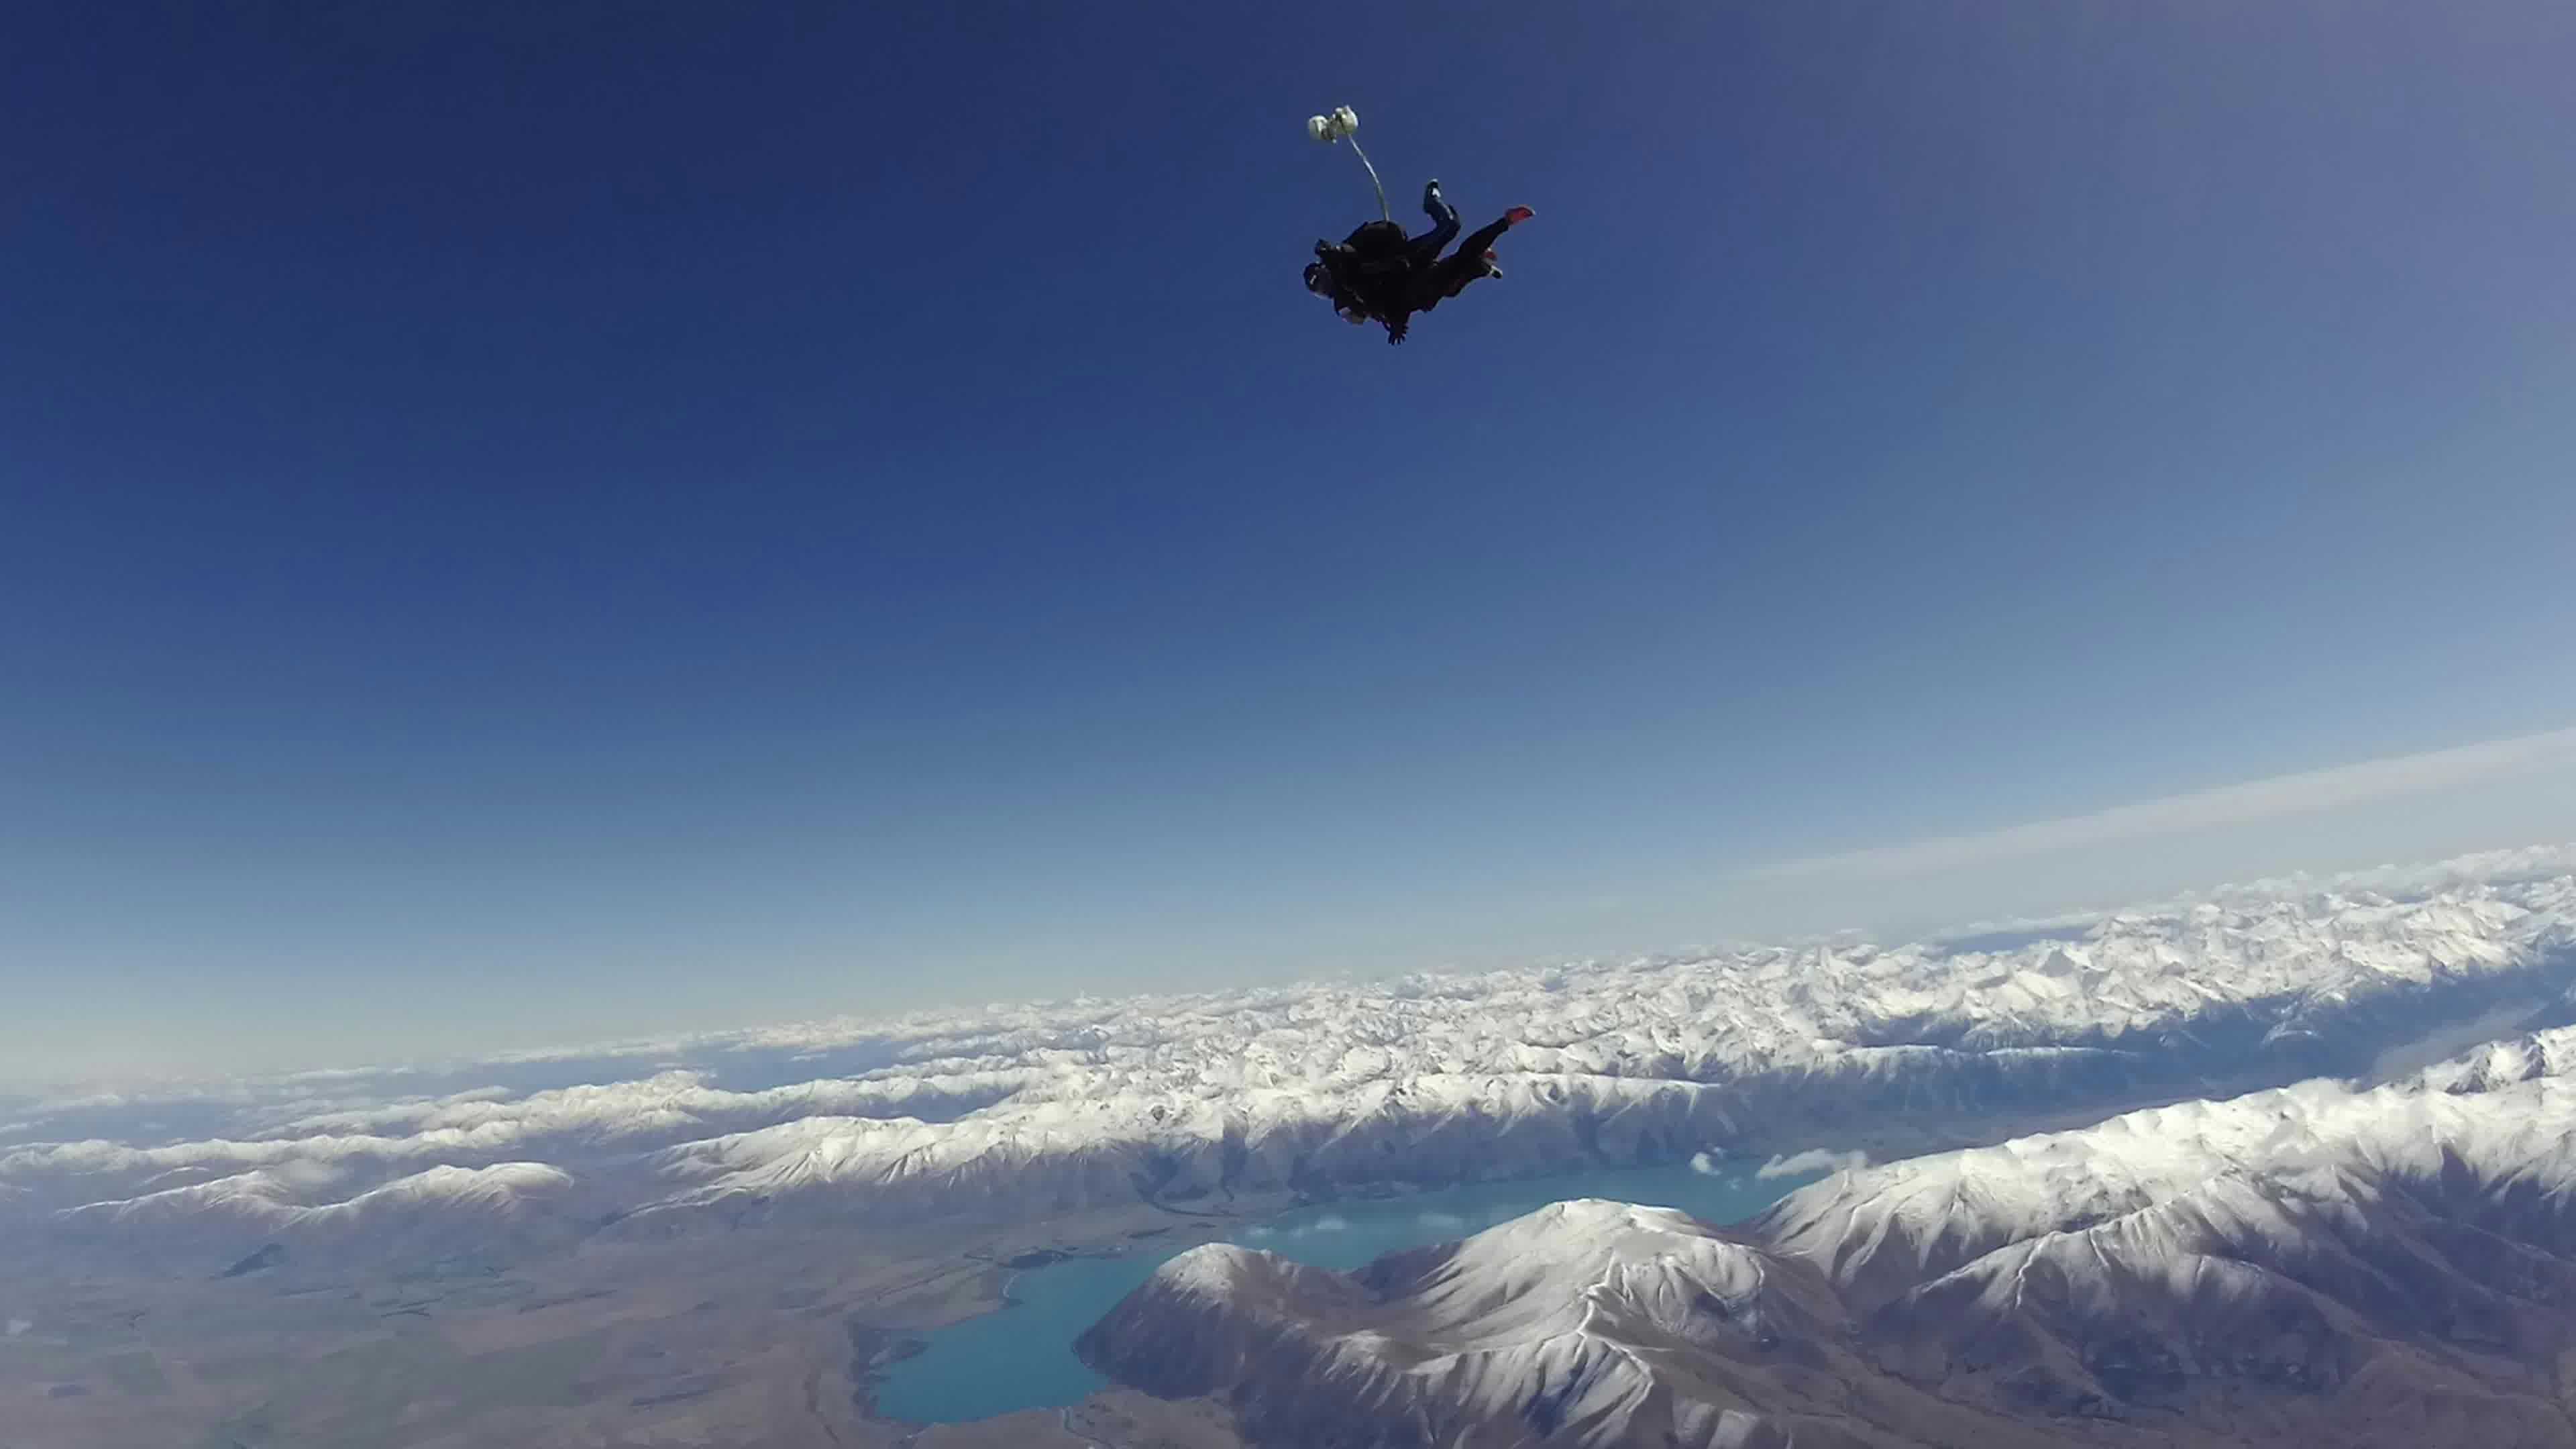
[1744,727,2576,881]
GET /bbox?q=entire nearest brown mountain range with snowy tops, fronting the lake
[1082,1029,2576,1449]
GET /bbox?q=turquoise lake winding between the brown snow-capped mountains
[876,1163,1821,1424]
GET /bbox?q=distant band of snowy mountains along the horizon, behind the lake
[0,851,2576,1263]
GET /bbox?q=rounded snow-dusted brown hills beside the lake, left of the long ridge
[1079,1201,1955,1449]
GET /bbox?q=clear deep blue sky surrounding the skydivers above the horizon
[0,0,2576,1075]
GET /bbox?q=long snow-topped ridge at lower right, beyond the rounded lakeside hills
[1749,1029,2576,1444]
